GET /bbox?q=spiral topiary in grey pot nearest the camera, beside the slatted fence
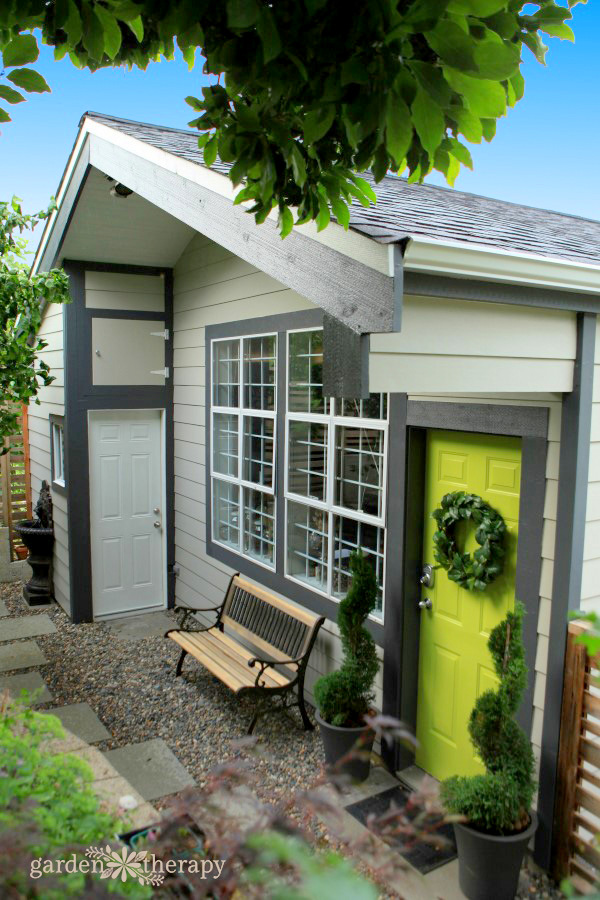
[442,602,537,900]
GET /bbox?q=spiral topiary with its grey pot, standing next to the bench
[314,548,379,781]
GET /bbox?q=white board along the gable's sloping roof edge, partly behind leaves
[82,118,389,275]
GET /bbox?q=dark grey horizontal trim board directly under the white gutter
[404,270,600,313]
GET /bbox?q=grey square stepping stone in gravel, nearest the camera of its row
[104,738,196,800]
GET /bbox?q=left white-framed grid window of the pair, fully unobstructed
[210,334,277,569]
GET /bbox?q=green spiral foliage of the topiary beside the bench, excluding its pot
[314,549,379,728]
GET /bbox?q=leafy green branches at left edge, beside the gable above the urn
[0,197,69,452]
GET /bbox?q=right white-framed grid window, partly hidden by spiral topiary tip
[285,328,388,620]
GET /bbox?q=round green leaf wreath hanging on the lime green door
[432,491,506,591]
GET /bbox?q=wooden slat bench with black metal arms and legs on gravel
[165,575,325,734]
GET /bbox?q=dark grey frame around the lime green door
[383,401,548,792]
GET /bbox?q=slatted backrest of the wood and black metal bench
[221,575,321,660]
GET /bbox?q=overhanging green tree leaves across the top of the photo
[0,0,585,235]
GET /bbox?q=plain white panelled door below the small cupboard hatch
[89,410,166,617]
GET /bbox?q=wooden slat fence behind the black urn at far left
[0,406,32,559]
